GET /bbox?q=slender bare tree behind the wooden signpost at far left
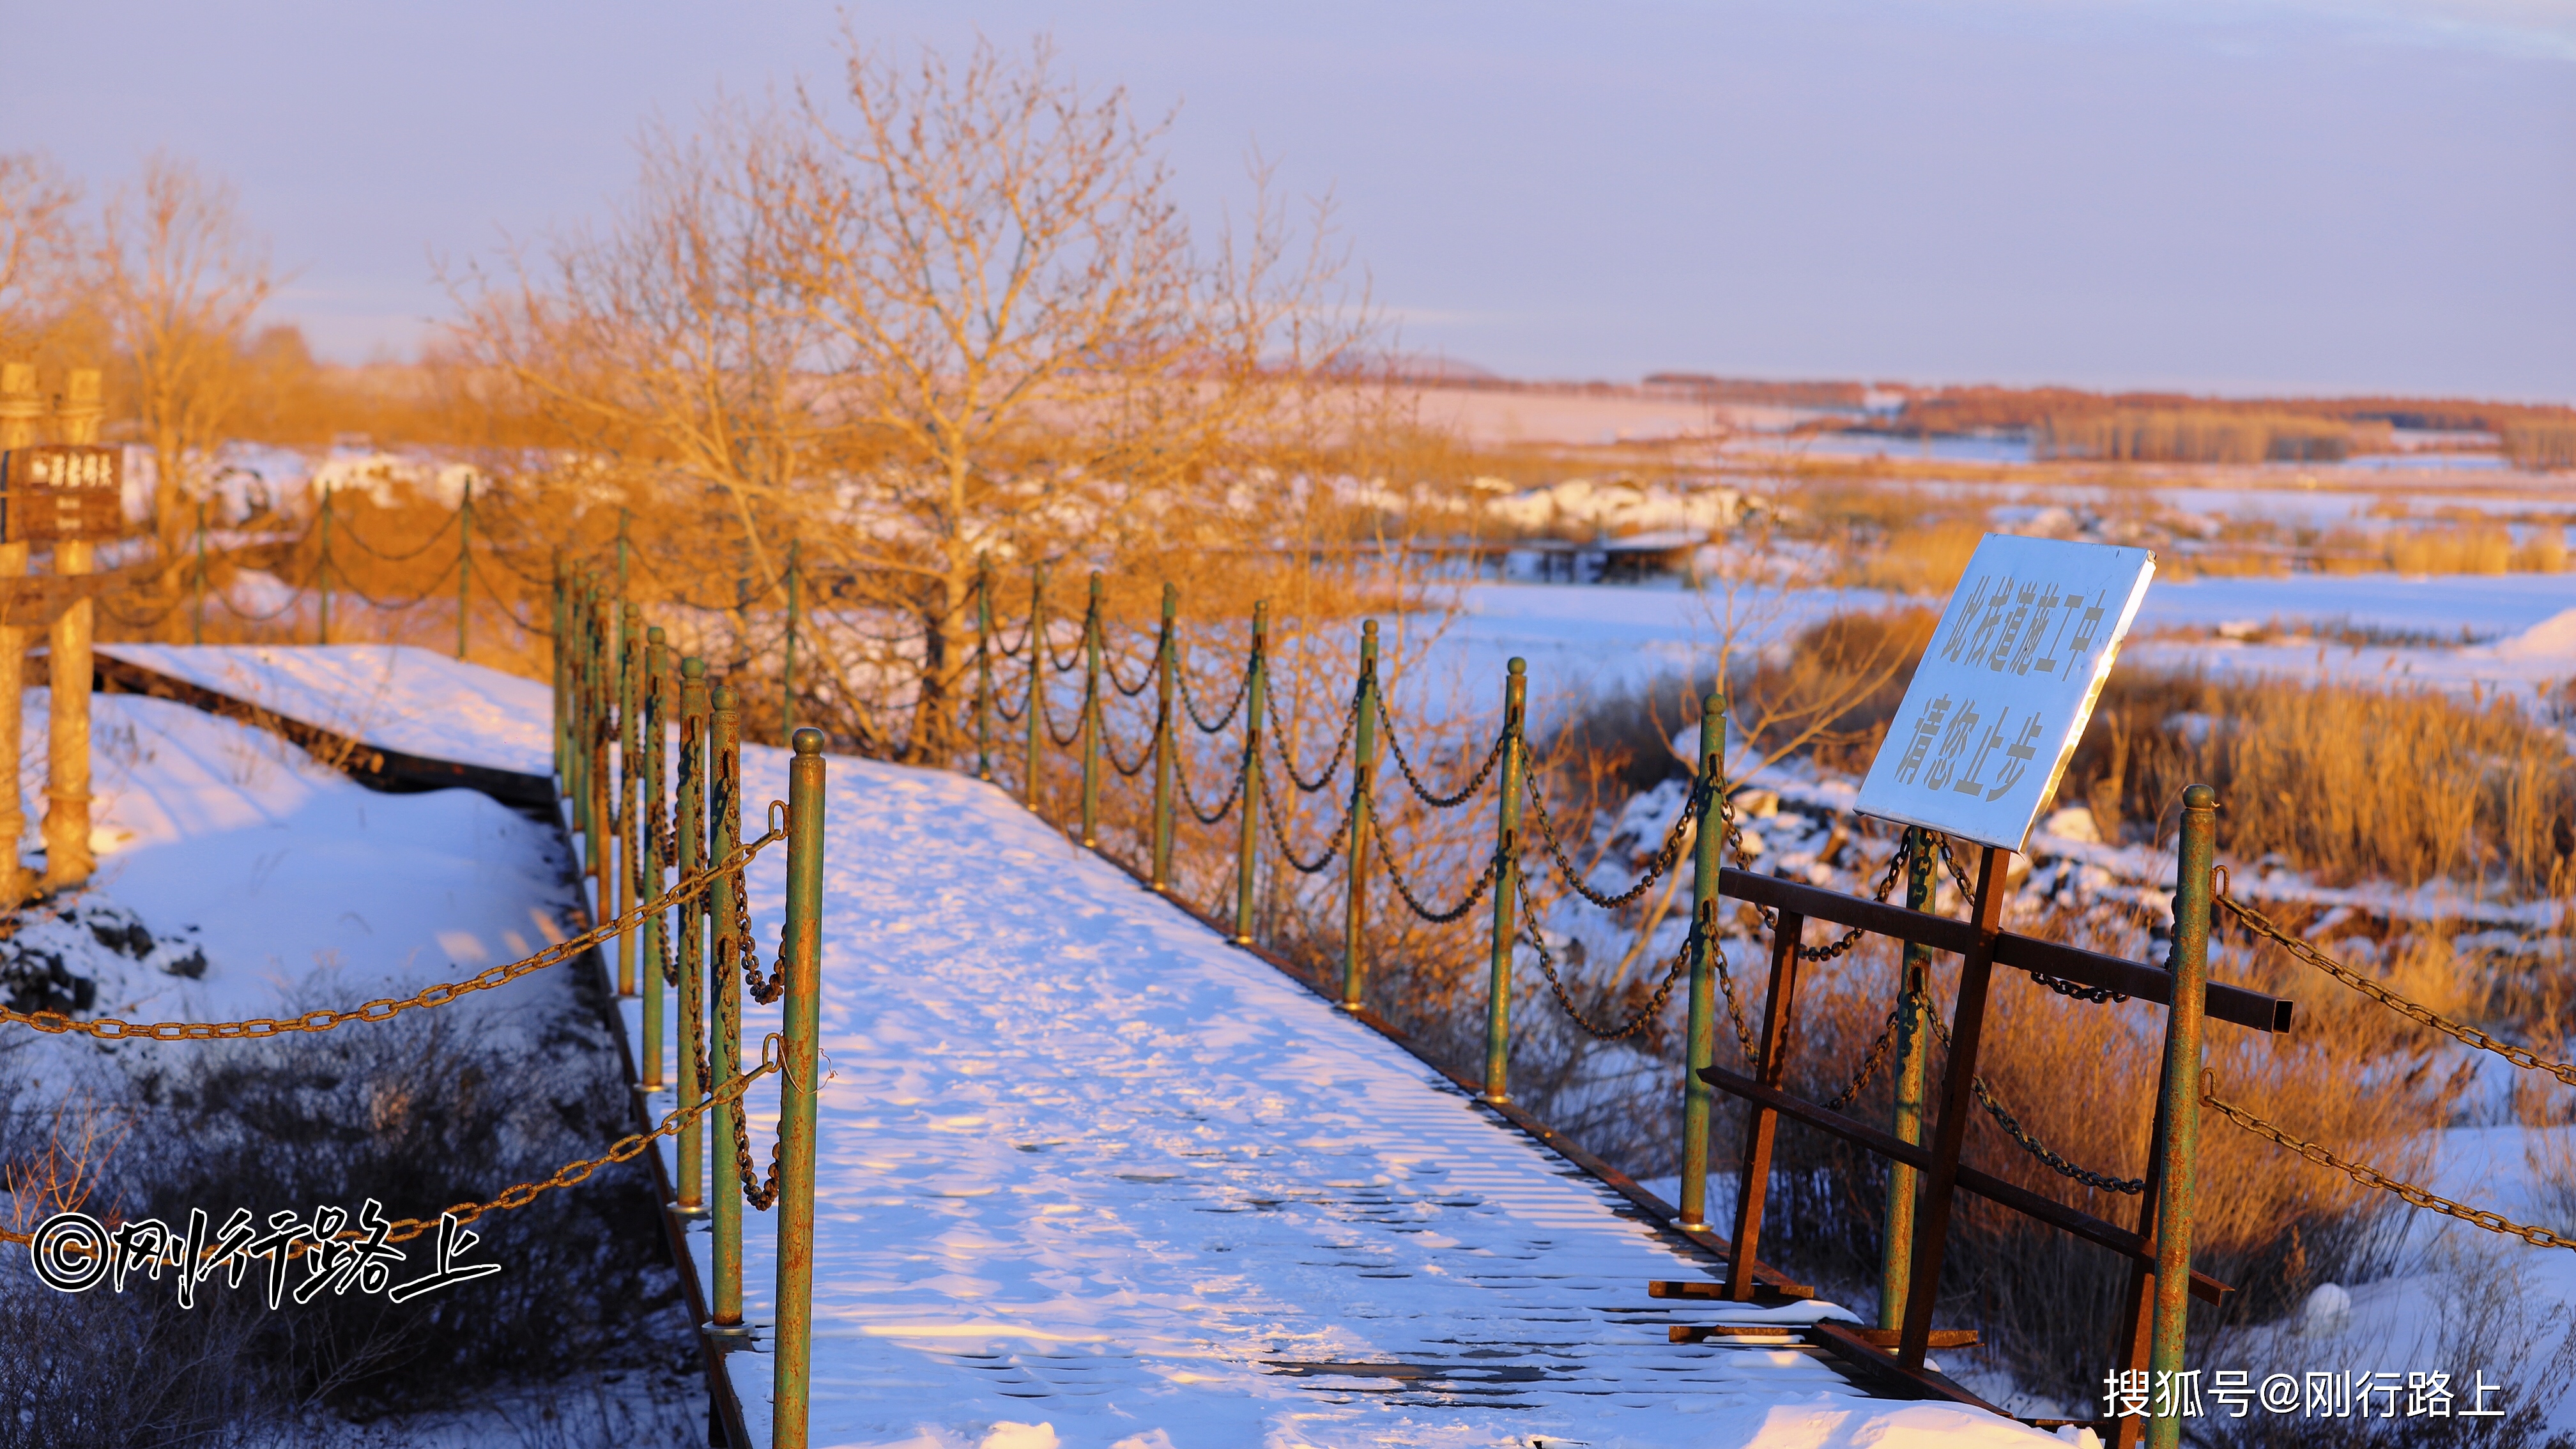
[90,155,280,578]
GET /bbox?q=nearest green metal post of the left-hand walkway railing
[770,730,824,1449]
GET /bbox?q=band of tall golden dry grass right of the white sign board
[2058,668,2576,894]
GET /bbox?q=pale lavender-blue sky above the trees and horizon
[20,0,2576,400]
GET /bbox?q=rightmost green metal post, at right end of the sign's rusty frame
[2146,784,2218,1449]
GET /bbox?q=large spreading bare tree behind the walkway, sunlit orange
[469,31,1360,755]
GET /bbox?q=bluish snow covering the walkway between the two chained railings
[626,747,2056,1449]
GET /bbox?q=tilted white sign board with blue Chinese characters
[1857,533,2156,851]
